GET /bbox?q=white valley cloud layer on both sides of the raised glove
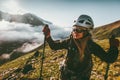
[0,21,71,42]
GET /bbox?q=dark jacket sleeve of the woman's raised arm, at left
[47,37,69,50]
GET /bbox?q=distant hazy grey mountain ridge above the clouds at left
[0,11,52,26]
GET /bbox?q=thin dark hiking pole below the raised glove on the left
[39,36,46,80]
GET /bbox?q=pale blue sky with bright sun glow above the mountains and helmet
[0,0,120,27]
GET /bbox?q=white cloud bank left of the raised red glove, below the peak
[0,21,43,41]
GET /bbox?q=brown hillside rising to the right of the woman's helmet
[93,20,120,39]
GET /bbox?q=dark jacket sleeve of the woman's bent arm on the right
[89,41,118,63]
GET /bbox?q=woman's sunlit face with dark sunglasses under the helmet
[72,26,86,39]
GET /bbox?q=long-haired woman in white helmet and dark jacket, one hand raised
[43,15,118,80]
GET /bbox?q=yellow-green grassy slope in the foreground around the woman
[0,39,120,80]
